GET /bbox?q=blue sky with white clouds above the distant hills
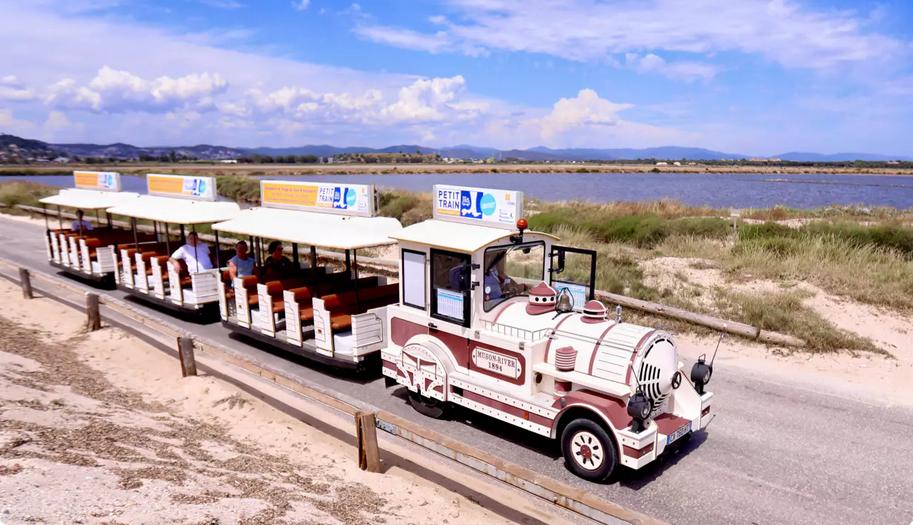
[0,0,913,155]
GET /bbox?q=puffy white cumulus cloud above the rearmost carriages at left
[46,66,228,113]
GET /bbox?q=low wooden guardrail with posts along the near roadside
[0,258,662,525]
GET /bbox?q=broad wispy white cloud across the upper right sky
[356,0,909,72]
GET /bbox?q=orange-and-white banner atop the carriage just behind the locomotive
[260,180,374,217]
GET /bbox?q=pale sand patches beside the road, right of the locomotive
[642,257,913,406]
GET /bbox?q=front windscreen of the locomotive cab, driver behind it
[482,242,545,312]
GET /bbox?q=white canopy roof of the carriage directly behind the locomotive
[212,208,403,250]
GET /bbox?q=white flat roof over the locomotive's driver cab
[391,219,558,253]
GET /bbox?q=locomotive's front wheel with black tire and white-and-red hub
[561,418,618,482]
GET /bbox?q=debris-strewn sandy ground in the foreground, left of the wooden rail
[0,281,507,524]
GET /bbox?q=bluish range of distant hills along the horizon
[0,135,913,162]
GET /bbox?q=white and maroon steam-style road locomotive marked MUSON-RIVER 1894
[381,185,713,480]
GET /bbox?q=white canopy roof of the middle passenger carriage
[108,195,241,224]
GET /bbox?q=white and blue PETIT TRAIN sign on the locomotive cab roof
[433,184,523,230]
